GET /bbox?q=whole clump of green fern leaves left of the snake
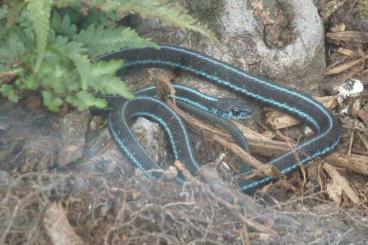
[0,0,215,111]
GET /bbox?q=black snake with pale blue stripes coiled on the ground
[99,45,341,192]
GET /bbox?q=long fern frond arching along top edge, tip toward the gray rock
[96,0,218,42]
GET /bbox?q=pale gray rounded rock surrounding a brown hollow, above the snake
[216,0,325,89]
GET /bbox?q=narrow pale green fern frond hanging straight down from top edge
[27,0,52,73]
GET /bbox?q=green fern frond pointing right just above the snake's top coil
[74,25,156,57]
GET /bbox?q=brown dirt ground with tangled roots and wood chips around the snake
[0,0,368,244]
